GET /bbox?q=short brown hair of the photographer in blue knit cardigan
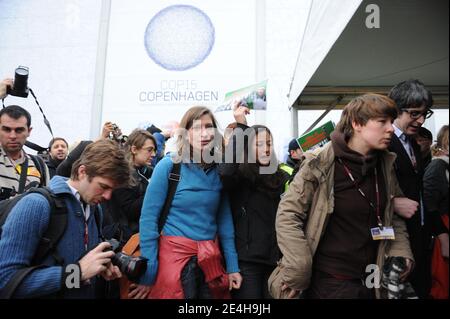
[71,139,131,186]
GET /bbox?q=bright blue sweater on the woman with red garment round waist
[139,156,239,285]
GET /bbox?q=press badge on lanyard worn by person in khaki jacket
[338,158,395,240]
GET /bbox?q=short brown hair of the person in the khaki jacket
[336,93,398,138]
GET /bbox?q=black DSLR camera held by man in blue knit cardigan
[106,238,148,282]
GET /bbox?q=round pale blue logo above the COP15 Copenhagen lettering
[144,5,215,71]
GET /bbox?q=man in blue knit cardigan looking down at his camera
[0,140,130,298]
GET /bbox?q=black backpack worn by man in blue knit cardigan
[0,187,86,299]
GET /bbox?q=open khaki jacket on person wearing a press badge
[269,142,414,299]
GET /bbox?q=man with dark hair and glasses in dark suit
[389,80,433,298]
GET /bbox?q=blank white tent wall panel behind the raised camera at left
[0,0,102,151]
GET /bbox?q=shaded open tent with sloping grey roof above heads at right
[293,0,449,141]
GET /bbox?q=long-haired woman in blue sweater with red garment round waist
[135,107,242,299]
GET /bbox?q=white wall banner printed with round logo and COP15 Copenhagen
[102,0,255,133]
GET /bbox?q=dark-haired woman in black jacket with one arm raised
[220,105,289,299]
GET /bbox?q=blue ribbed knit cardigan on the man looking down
[0,176,100,298]
